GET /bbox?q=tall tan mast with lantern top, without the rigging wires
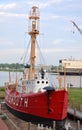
[28,6,40,80]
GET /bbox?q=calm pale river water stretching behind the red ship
[0,71,82,87]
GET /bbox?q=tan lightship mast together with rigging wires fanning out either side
[20,6,45,76]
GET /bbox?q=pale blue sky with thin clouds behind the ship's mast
[0,0,82,65]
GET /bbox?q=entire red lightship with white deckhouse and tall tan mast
[5,6,68,130]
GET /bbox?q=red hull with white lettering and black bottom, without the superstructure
[5,90,68,127]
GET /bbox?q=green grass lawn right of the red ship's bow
[68,88,82,110]
